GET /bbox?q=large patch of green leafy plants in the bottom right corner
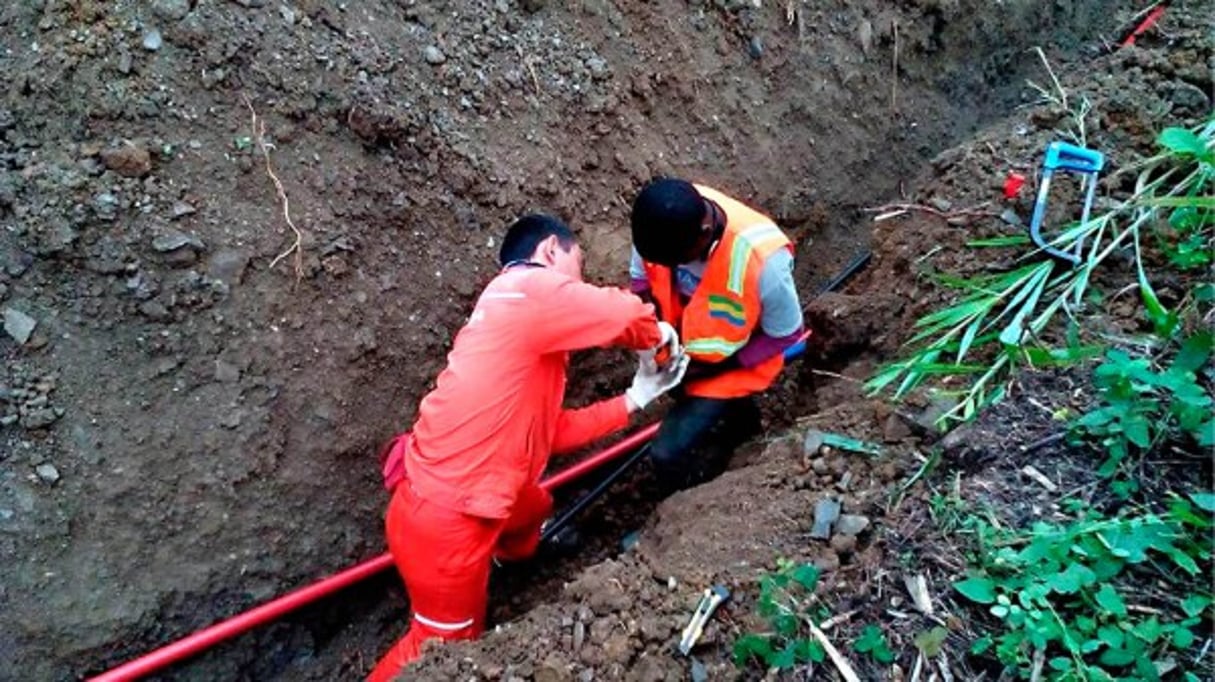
[954,495,1215,681]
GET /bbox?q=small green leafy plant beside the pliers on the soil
[734,559,826,670]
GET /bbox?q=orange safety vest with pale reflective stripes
[645,185,793,399]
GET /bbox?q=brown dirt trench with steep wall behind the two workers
[0,0,1132,680]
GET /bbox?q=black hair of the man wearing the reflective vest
[632,177,705,266]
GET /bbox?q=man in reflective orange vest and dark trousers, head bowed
[629,177,804,492]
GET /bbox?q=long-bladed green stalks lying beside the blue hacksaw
[866,118,1215,421]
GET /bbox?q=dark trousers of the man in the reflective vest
[650,395,762,495]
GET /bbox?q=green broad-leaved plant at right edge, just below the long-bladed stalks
[1074,332,1215,475]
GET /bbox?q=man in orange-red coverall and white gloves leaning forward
[368,215,688,682]
